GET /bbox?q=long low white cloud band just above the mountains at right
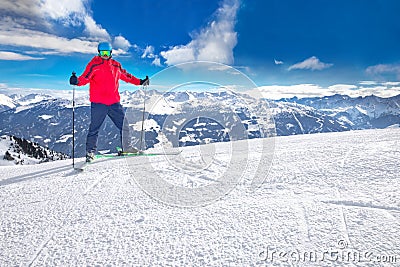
[247,83,400,100]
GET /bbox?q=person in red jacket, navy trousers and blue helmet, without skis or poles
[69,42,150,162]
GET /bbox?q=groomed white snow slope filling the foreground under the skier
[0,128,400,266]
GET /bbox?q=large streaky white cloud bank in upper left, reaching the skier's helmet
[0,0,131,55]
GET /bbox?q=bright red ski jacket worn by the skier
[78,56,140,105]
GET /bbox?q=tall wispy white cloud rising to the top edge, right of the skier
[160,0,239,65]
